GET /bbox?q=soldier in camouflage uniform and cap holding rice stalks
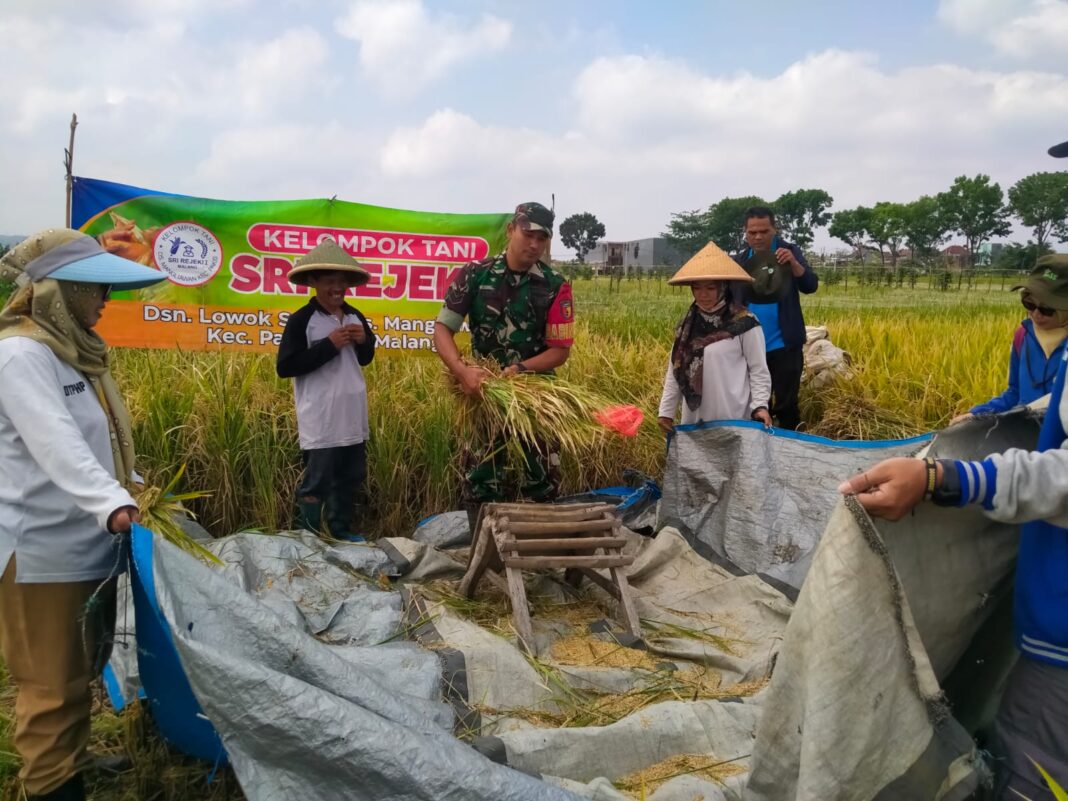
[434,203,575,527]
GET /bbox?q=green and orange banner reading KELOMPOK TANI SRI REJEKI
[73,177,511,350]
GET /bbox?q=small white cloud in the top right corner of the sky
[938,0,1068,69]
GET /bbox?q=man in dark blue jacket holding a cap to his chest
[733,206,819,430]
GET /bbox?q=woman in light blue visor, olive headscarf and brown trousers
[0,229,164,801]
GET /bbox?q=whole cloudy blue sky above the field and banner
[0,0,1068,253]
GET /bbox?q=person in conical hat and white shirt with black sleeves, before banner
[278,237,375,543]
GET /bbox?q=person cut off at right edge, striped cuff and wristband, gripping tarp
[839,135,1068,801]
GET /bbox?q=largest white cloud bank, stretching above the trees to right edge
[380,50,1068,247]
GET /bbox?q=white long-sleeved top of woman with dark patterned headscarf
[657,326,771,424]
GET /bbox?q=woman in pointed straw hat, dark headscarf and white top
[658,242,771,434]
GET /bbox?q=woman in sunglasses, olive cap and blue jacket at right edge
[951,253,1068,425]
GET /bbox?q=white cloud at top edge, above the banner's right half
[335,0,512,94]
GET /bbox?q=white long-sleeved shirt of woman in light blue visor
[0,336,135,583]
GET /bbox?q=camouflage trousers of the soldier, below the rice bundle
[464,440,560,504]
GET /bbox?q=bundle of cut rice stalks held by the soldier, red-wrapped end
[451,360,641,467]
